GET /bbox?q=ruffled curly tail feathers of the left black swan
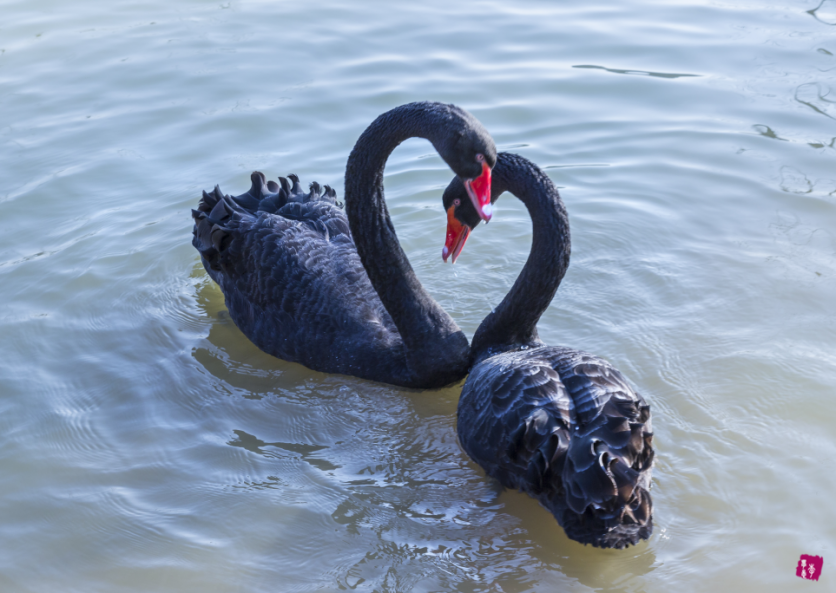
[192,171,341,271]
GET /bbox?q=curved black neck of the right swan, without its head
[471,153,571,360]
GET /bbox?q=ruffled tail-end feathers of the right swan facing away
[549,397,654,549]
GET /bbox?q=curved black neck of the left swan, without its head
[345,103,469,387]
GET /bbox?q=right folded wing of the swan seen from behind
[548,348,654,548]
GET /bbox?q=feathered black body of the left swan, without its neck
[192,172,405,382]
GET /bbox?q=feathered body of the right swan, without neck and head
[458,346,654,548]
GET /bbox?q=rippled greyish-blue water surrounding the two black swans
[0,0,836,592]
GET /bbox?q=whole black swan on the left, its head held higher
[192,103,496,388]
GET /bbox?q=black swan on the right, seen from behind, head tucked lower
[443,153,654,548]
